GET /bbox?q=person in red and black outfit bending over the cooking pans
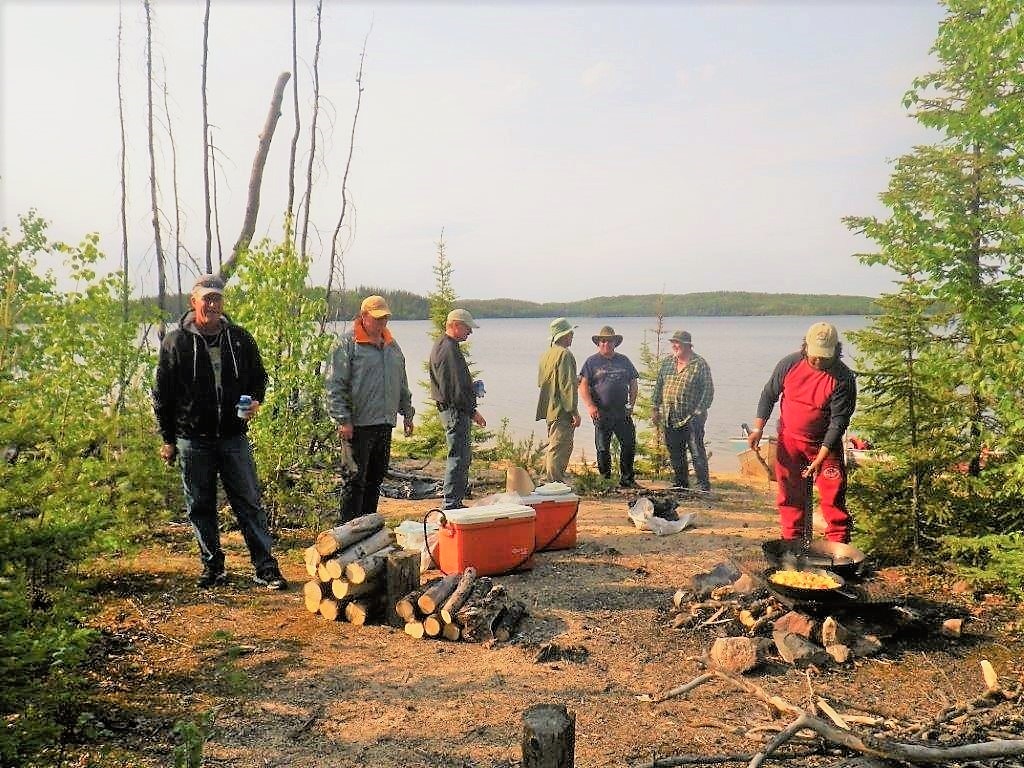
[746,323,857,543]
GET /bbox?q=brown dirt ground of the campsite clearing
[86,476,1024,768]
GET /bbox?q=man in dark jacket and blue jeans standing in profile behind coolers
[430,309,487,509]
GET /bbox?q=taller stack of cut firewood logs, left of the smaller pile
[303,513,420,627]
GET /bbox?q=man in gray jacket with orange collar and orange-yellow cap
[326,296,416,522]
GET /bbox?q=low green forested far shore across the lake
[142,284,879,319]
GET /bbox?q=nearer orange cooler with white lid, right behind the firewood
[437,504,537,575]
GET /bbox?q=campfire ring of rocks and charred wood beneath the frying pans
[668,563,961,674]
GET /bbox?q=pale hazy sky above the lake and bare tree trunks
[0,0,943,301]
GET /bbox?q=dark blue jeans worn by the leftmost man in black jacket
[177,434,278,573]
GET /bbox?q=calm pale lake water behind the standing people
[344,316,868,472]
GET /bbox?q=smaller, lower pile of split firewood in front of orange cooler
[394,567,526,643]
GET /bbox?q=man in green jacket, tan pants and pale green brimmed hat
[537,317,580,482]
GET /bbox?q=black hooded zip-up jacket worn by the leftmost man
[153,311,267,443]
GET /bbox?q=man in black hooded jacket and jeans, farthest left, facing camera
[153,274,288,590]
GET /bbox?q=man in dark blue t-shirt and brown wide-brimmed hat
[580,326,640,488]
